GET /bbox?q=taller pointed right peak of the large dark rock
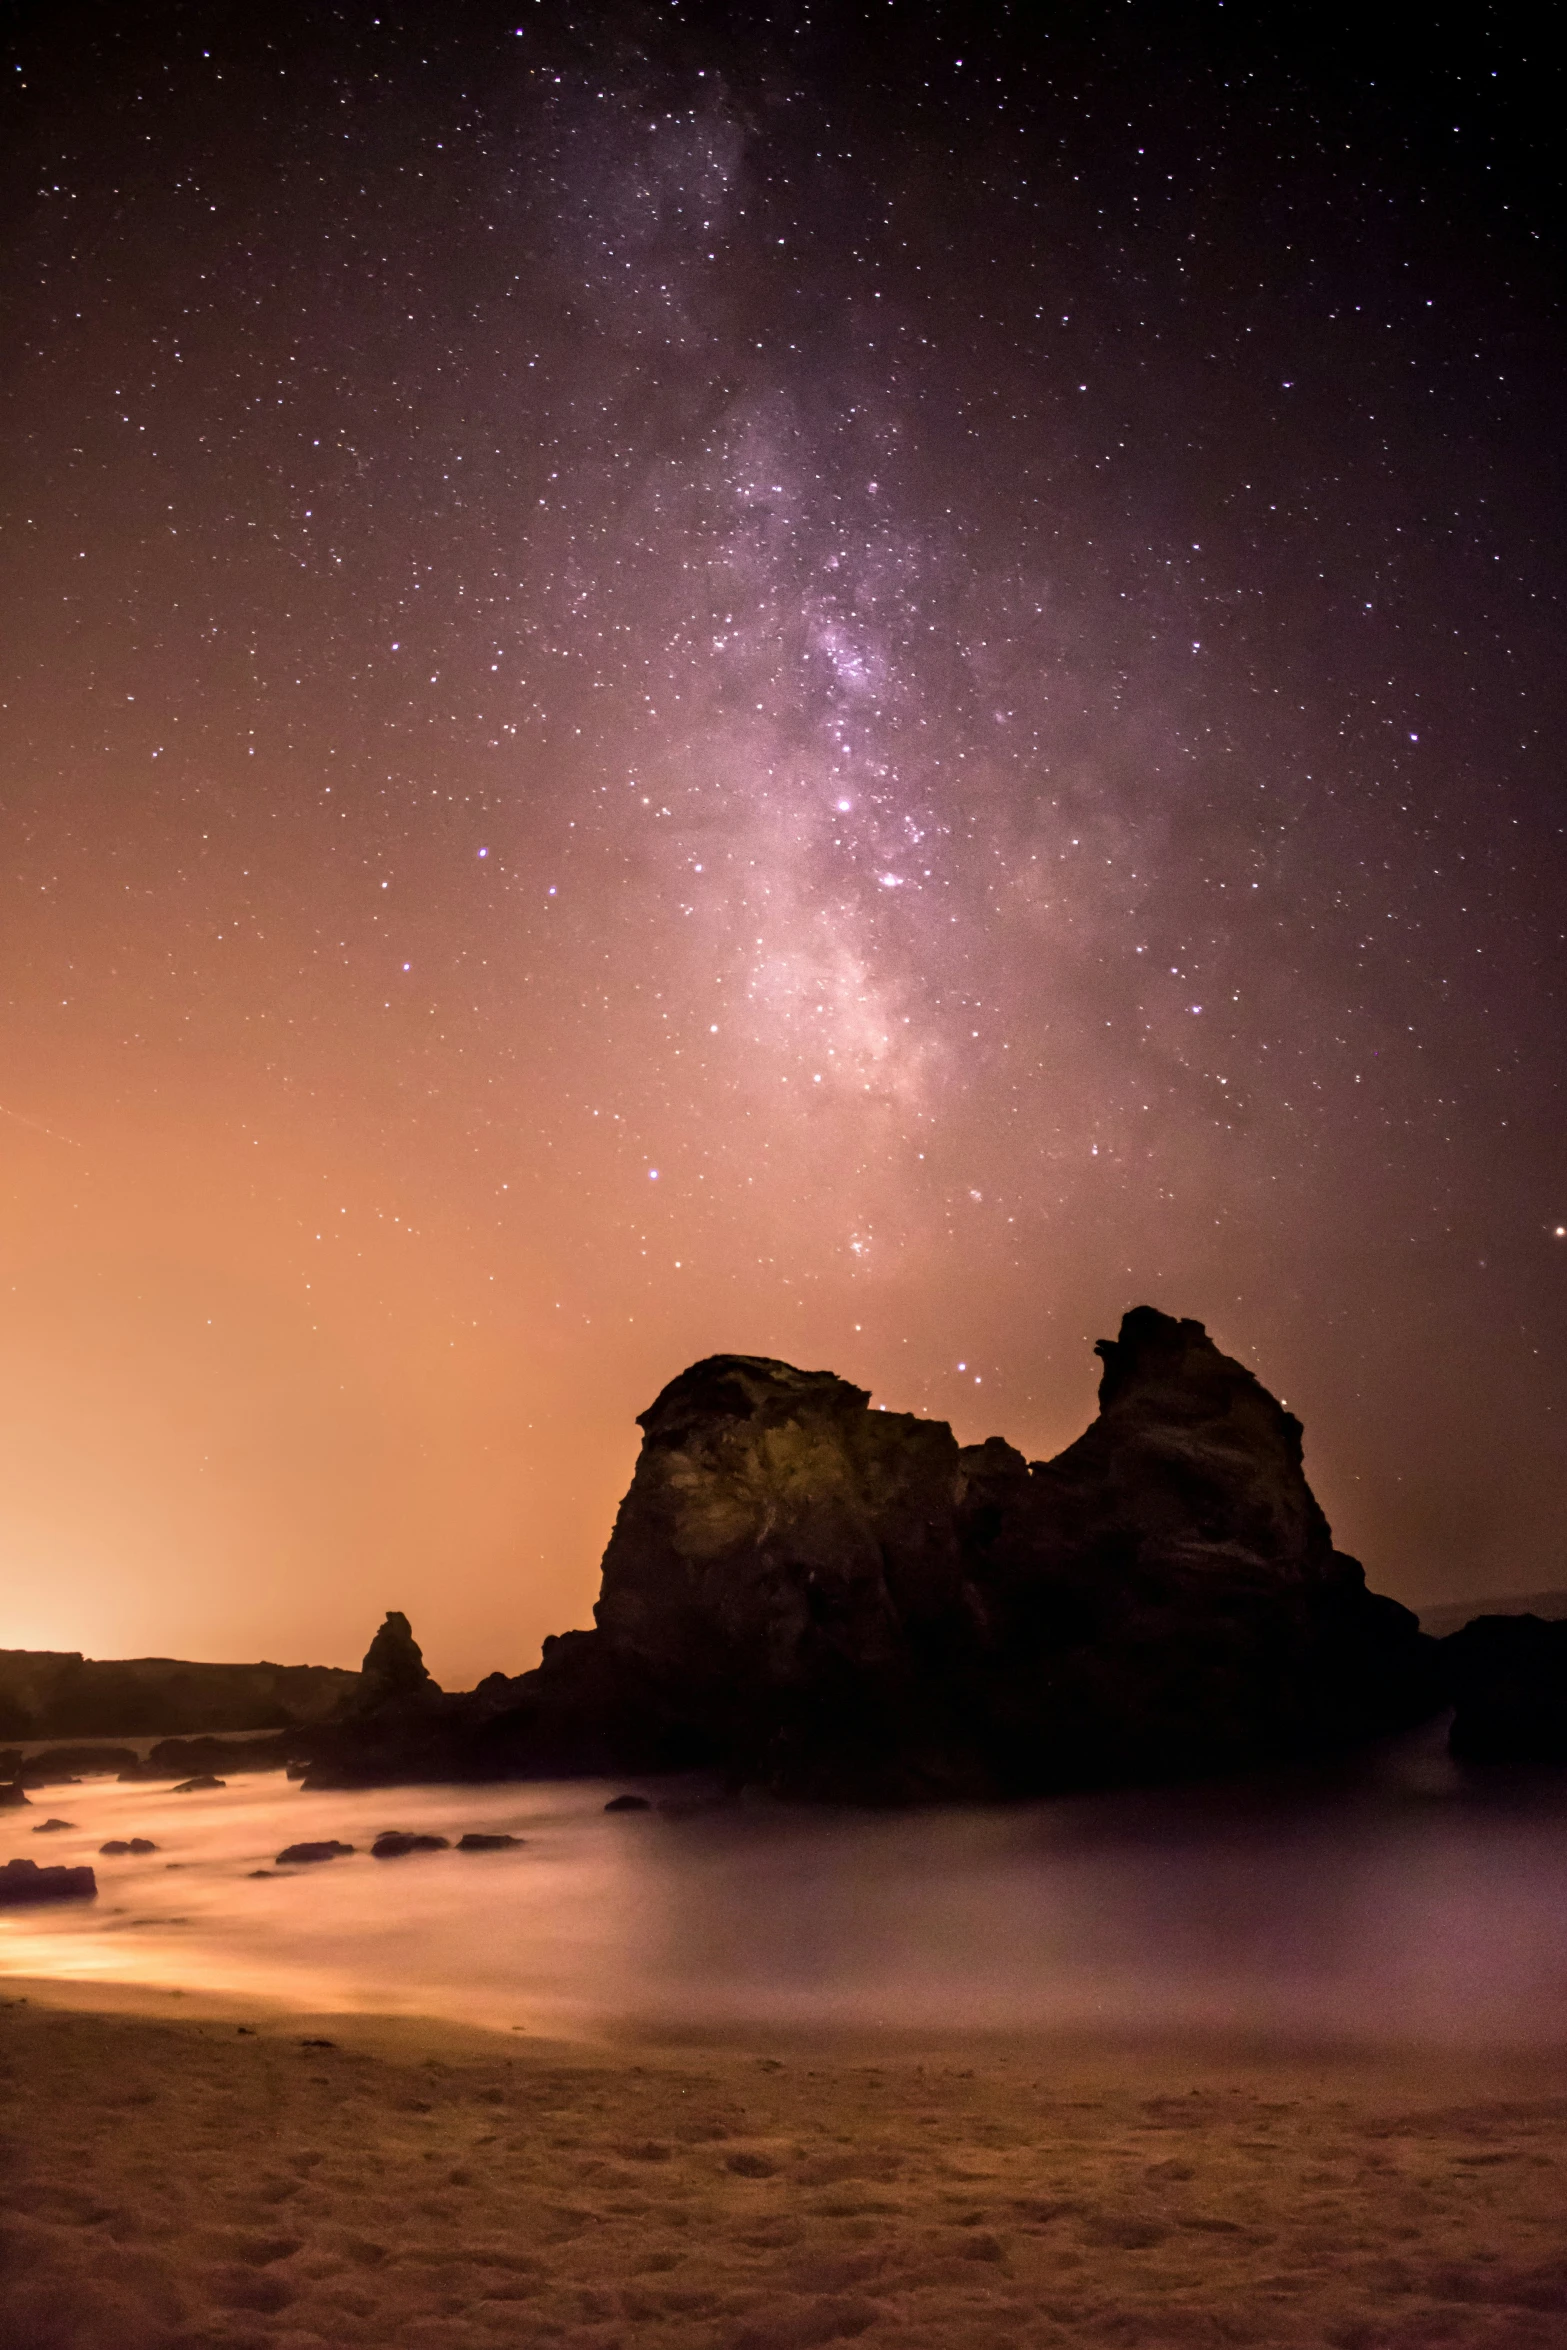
[966,1307,1438,1784]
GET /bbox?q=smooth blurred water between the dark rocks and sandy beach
[0,1730,1567,2042]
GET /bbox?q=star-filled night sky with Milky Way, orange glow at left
[0,0,1567,1685]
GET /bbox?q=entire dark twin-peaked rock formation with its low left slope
[310,1307,1440,1800]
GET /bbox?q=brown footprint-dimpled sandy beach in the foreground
[0,2000,1567,2350]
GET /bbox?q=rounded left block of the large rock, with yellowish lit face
[594,1356,967,1763]
